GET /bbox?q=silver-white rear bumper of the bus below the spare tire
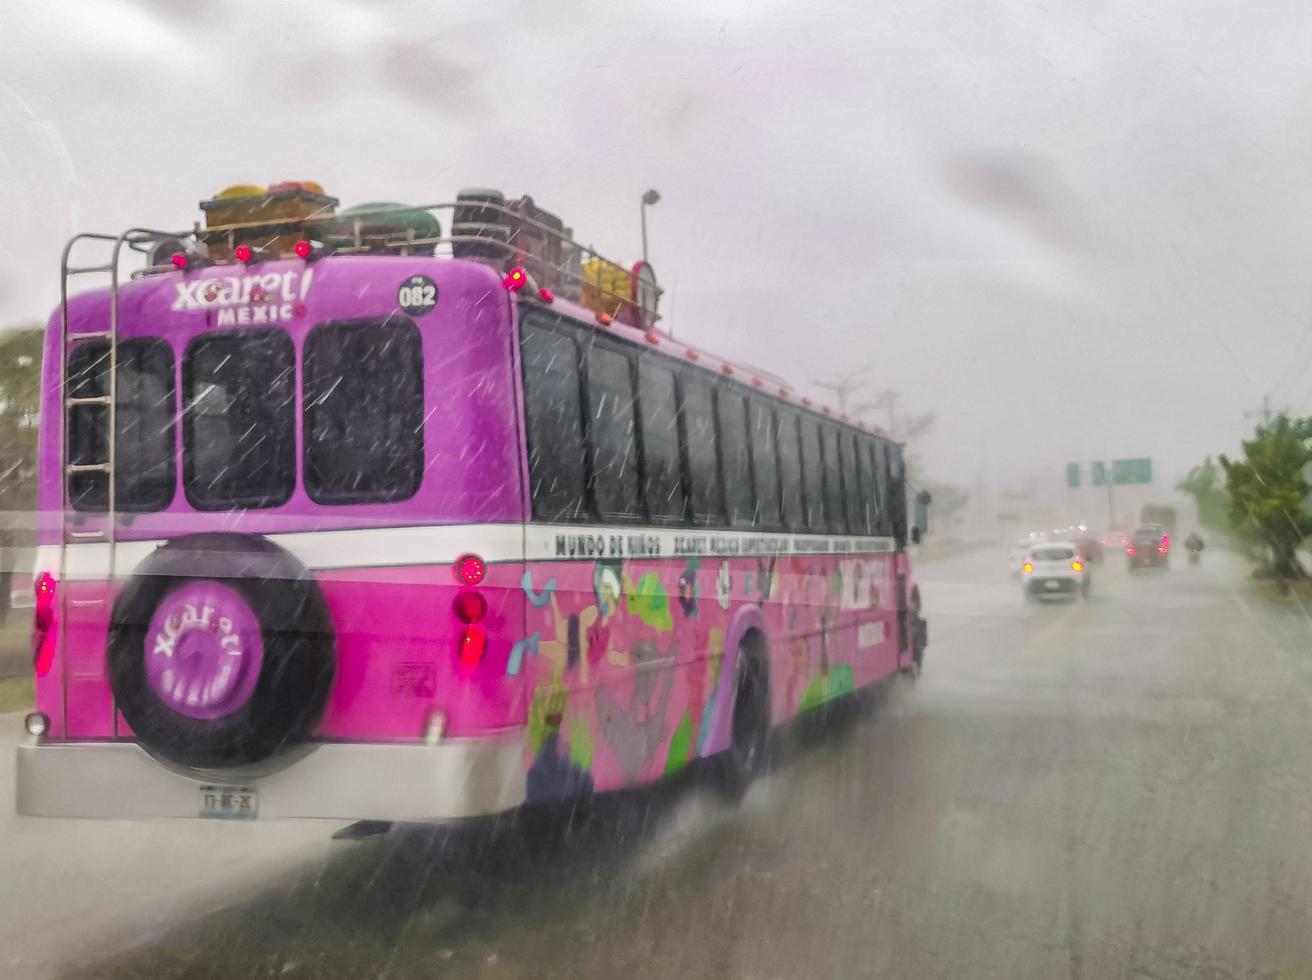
[14,728,526,821]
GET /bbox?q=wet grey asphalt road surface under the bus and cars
[0,551,1312,980]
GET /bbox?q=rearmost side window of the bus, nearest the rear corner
[520,317,588,521]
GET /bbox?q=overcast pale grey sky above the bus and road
[0,0,1312,506]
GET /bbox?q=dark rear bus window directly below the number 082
[303,317,424,504]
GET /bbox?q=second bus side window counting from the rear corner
[588,344,643,520]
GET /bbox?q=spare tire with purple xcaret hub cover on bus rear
[108,534,336,769]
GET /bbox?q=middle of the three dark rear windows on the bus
[182,329,297,510]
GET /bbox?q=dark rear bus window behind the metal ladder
[68,338,177,513]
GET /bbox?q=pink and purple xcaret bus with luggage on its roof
[17,182,928,821]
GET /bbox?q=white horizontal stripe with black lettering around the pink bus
[34,523,895,579]
